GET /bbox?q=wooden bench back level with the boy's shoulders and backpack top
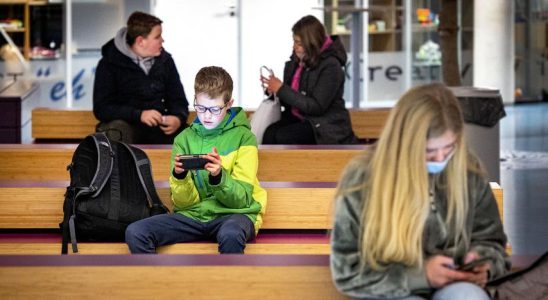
[0,144,367,182]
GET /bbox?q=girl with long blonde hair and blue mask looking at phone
[331,83,510,299]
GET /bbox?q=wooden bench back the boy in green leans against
[0,180,336,229]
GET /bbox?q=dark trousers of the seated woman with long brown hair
[263,115,317,145]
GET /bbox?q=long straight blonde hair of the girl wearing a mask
[361,83,469,269]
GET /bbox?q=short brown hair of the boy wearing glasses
[194,66,233,103]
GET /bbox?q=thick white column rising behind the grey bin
[474,0,515,103]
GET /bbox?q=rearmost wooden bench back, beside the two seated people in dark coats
[32,107,390,141]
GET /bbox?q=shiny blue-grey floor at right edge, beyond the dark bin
[500,103,548,255]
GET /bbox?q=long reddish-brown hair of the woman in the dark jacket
[291,15,327,66]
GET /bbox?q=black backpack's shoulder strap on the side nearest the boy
[119,142,168,215]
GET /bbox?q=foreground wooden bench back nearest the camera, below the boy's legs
[0,255,348,300]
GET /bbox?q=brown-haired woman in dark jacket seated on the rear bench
[261,16,357,144]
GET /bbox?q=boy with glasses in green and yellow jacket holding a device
[126,67,267,253]
